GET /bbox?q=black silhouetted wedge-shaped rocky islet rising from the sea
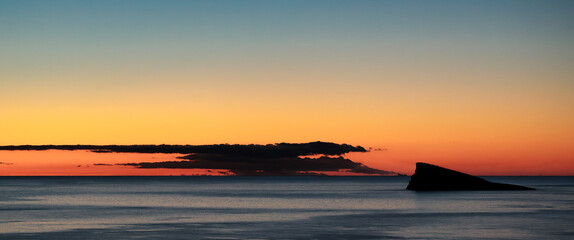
[407,162,534,191]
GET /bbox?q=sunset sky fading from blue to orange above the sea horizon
[0,0,574,175]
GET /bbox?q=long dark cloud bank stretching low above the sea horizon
[0,142,395,175]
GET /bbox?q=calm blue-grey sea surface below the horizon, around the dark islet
[0,177,574,240]
